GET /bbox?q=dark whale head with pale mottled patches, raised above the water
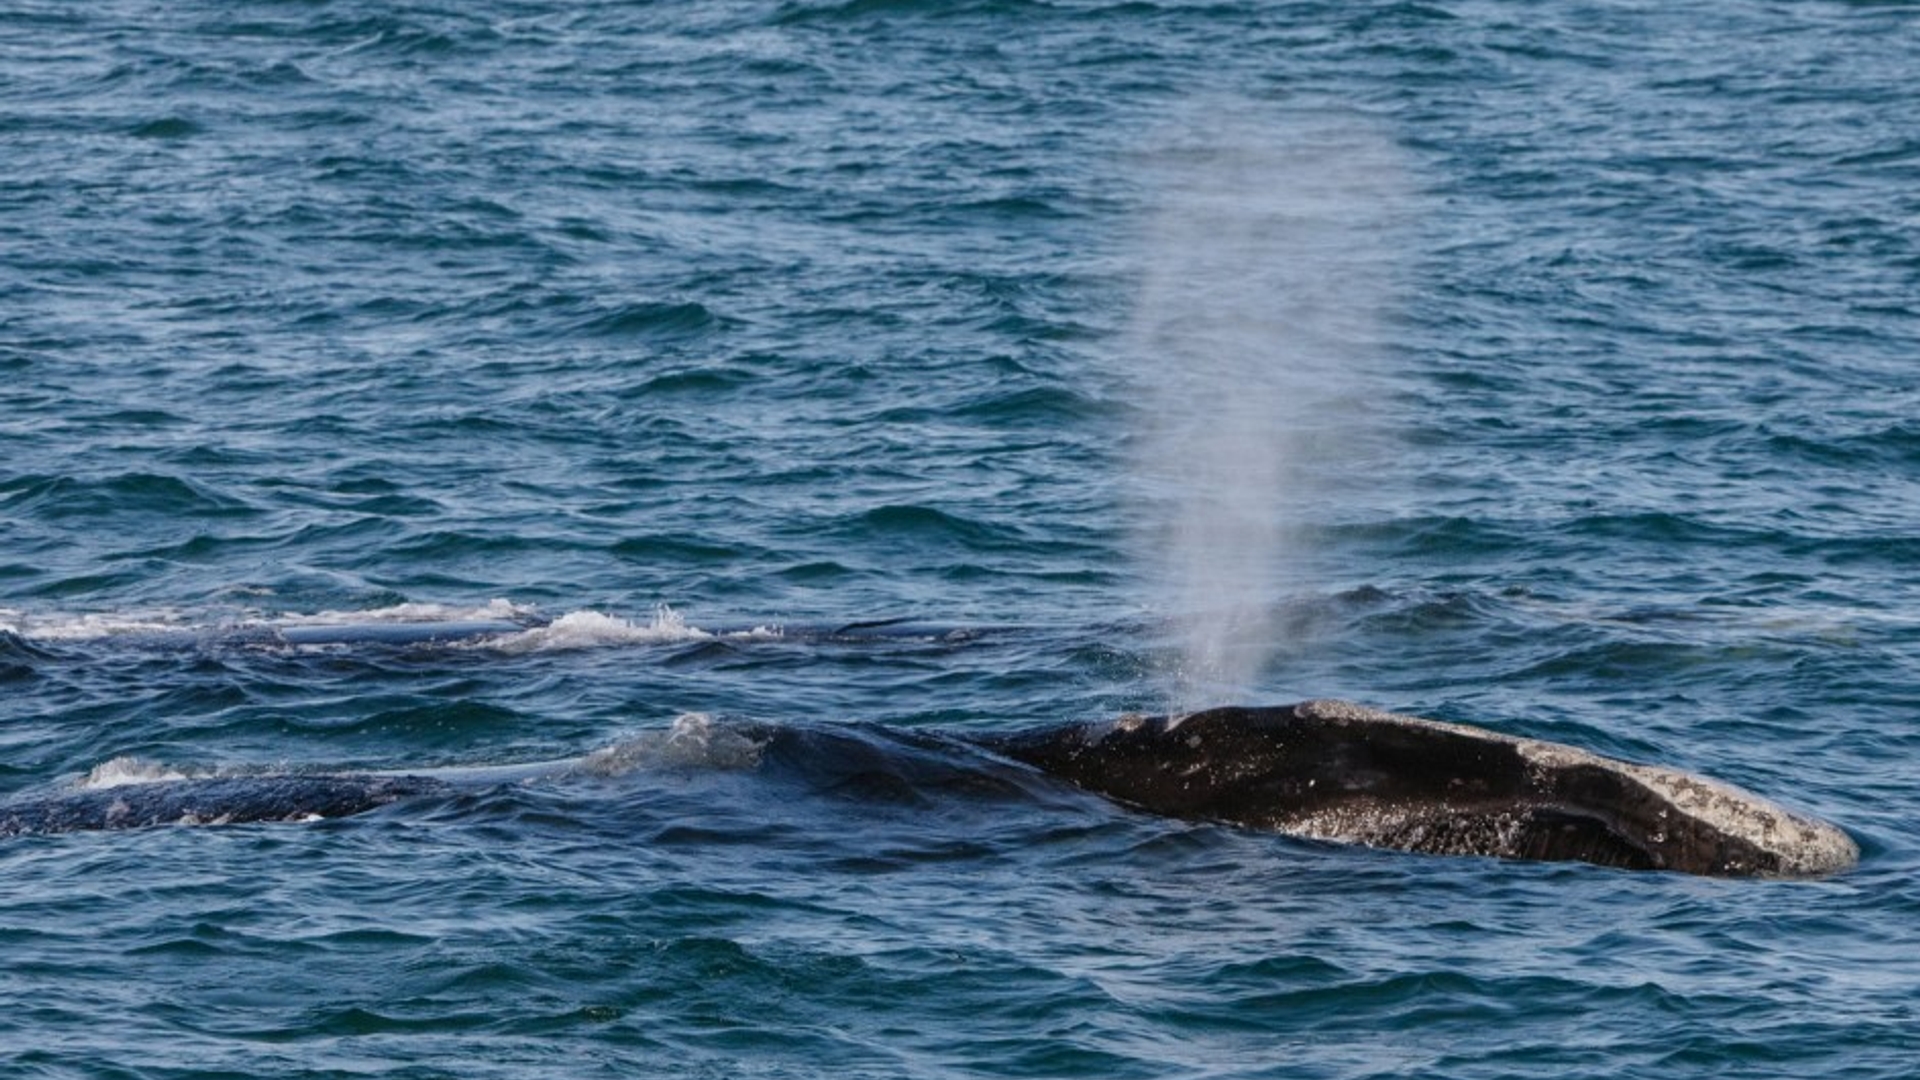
[979,701,1860,878]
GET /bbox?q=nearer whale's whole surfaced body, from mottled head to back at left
[0,700,1859,878]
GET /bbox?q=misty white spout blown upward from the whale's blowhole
[1127,102,1407,711]
